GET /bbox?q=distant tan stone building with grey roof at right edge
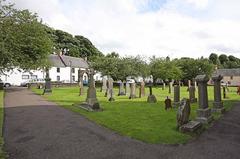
[214,68,240,86]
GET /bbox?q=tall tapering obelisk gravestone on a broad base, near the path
[77,69,100,111]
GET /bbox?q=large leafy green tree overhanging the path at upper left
[0,0,52,72]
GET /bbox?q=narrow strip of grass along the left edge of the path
[0,90,5,159]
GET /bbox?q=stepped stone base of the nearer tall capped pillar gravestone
[196,108,213,123]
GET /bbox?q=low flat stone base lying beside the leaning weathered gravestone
[179,121,202,133]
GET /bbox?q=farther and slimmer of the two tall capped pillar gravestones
[212,75,225,113]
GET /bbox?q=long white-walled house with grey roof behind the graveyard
[0,54,102,86]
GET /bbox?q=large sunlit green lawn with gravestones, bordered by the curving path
[33,87,239,144]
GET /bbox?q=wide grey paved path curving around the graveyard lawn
[4,88,240,159]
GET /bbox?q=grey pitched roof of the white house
[49,54,88,68]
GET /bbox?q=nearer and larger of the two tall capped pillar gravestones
[196,75,213,123]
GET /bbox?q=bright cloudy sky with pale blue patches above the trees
[10,0,240,58]
